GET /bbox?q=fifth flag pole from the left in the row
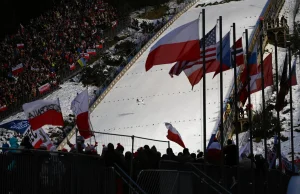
[259,20,268,161]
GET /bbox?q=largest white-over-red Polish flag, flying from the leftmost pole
[145,19,200,71]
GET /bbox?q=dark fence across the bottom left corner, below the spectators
[0,150,116,194]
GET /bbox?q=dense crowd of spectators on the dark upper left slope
[0,0,117,111]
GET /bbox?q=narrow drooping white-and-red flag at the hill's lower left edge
[71,90,93,139]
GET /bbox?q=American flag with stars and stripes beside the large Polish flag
[169,26,217,77]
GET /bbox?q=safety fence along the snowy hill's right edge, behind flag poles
[214,0,284,146]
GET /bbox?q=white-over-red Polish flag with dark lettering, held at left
[23,99,64,130]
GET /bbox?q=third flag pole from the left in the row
[232,23,240,193]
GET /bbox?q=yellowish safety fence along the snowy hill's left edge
[59,0,198,150]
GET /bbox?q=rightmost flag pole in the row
[288,41,297,173]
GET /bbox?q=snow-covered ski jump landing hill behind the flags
[58,0,278,153]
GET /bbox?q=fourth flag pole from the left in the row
[245,29,255,193]
